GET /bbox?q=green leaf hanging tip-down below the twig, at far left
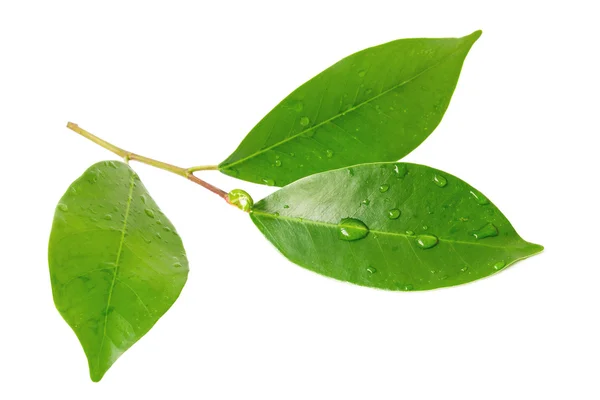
[48,161,188,382]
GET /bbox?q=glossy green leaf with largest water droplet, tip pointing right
[251,163,543,290]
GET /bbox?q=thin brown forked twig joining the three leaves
[67,122,229,203]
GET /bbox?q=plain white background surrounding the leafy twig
[0,0,600,400]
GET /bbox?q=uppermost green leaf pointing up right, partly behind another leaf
[219,31,481,186]
